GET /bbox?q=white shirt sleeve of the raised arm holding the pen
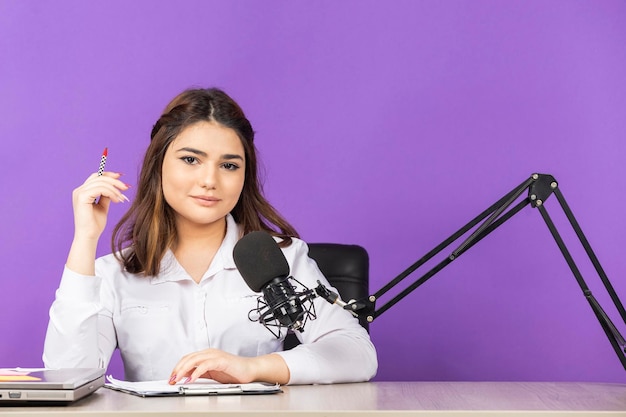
[43,267,117,368]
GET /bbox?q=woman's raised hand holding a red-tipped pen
[72,172,129,241]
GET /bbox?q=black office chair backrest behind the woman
[283,243,369,350]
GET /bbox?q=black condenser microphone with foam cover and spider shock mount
[233,231,316,337]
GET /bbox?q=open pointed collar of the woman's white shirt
[150,214,241,284]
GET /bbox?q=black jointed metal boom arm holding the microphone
[334,174,626,369]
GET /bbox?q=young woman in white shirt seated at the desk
[43,89,378,384]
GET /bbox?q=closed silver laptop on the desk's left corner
[0,368,105,405]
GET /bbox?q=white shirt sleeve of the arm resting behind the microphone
[277,239,378,385]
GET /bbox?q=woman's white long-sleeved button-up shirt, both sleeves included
[43,215,378,384]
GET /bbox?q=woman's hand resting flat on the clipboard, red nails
[169,349,289,385]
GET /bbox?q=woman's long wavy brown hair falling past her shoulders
[111,88,298,276]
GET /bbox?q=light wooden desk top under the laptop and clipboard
[0,382,626,417]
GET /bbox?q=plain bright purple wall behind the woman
[0,0,626,382]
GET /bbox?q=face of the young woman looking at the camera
[162,122,246,231]
